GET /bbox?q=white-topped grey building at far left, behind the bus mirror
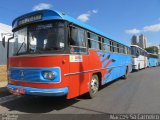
[0,23,13,65]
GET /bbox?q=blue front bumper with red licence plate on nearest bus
[7,84,68,96]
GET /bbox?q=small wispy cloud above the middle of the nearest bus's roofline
[77,10,98,22]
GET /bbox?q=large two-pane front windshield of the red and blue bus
[14,21,65,55]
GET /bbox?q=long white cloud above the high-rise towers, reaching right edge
[126,23,160,34]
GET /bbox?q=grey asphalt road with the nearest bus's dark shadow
[0,67,160,114]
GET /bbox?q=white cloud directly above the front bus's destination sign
[32,3,52,11]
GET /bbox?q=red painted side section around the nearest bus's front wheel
[67,50,106,98]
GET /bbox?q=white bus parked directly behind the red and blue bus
[131,45,148,71]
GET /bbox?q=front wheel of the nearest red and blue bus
[86,75,99,99]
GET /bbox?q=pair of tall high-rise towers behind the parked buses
[131,34,147,49]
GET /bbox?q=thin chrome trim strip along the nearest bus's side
[64,65,124,76]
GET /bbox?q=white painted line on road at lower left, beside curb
[0,95,21,104]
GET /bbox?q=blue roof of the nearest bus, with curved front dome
[12,10,130,47]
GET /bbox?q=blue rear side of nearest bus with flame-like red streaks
[98,52,132,84]
